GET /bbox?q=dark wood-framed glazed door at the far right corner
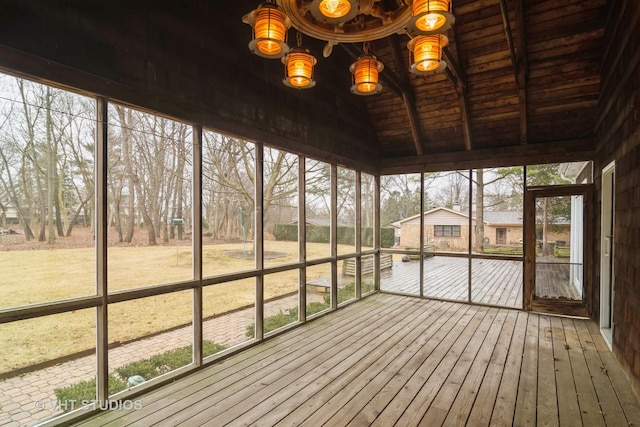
[524,185,593,316]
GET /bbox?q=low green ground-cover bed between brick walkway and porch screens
[54,340,226,412]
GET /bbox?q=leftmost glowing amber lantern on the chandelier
[243,3,291,59]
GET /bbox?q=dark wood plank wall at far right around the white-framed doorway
[593,0,640,395]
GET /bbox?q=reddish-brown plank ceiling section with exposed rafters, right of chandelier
[366,0,606,158]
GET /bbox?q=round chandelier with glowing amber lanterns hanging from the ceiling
[242,0,455,95]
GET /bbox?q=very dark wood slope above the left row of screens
[0,0,379,173]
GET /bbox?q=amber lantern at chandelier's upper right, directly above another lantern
[407,0,455,35]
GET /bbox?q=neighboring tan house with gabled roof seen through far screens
[391,207,523,251]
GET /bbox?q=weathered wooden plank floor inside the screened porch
[82,294,640,427]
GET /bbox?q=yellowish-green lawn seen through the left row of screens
[0,242,370,373]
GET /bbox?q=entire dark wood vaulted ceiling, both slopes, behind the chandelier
[0,0,608,173]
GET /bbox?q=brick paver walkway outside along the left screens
[0,295,322,426]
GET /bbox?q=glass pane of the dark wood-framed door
[535,195,584,301]
